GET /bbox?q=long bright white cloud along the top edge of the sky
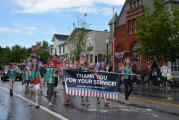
[15,0,125,13]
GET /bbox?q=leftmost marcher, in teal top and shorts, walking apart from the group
[8,63,17,96]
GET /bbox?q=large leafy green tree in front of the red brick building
[137,0,179,60]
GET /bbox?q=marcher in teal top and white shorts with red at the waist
[29,58,41,108]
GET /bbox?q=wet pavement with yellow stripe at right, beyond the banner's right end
[117,85,179,116]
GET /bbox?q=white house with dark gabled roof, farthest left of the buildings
[50,34,69,59]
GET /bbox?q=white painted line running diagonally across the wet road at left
[0,86,69,120]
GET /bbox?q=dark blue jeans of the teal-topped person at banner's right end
[124,79,132,100]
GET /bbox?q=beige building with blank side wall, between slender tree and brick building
[85,31,111,63]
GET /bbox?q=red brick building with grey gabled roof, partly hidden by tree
[109,0,179,69]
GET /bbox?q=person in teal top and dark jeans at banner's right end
[123,58,133,104]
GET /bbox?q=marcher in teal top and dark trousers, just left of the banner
[45,61,57,106]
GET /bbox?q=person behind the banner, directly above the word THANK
[78,54,89,105]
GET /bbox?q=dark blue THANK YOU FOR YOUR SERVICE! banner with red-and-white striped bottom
[64,70,120,99]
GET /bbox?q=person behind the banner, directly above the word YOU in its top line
[97,61,109,107]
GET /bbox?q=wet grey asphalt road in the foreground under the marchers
[0,81,179,120]
